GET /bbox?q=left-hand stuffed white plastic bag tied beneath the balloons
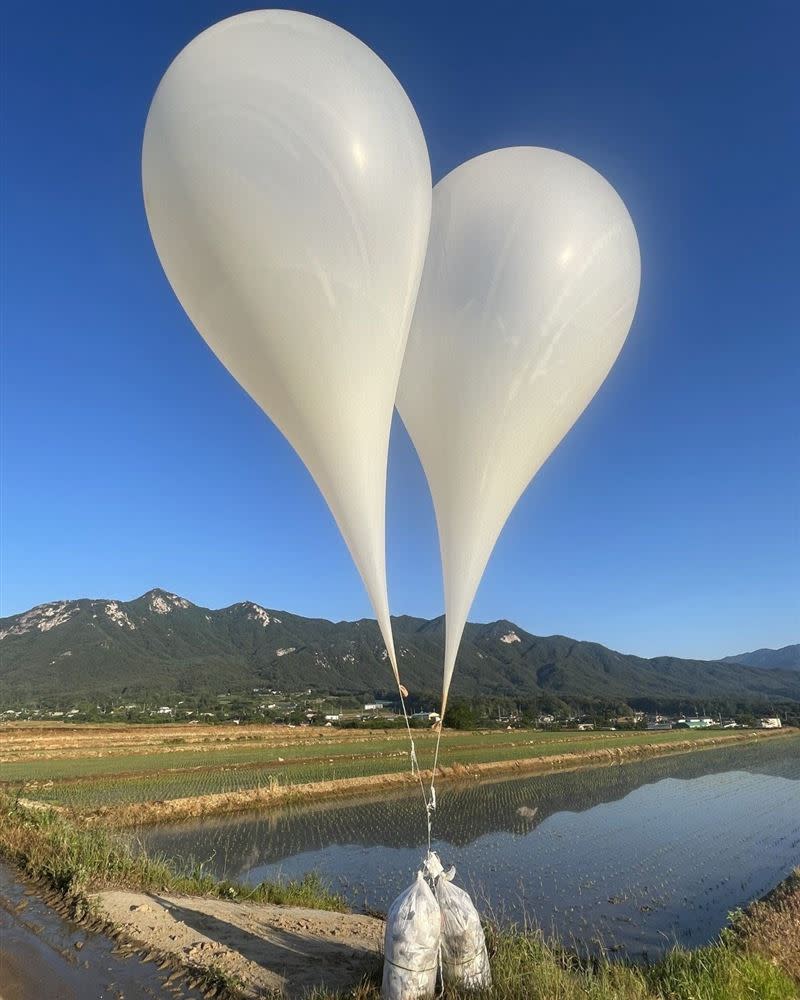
[381,872,442,1000]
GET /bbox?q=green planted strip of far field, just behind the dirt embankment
[0,730,764,812]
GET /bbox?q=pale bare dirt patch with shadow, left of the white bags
[92,891,383,997]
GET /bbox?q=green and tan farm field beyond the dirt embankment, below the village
[0,724,780,813]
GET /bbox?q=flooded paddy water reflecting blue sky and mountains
[144,739,800,954]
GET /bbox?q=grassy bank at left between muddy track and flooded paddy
[0,796,347,912]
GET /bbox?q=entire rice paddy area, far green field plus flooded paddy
[0,724,800,976]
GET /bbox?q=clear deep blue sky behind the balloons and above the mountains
[1,0,800,657]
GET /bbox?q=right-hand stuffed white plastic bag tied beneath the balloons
[436,868,492,989]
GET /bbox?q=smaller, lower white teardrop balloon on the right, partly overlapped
[397,147,640,705]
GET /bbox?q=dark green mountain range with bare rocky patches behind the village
[0,590,800,704]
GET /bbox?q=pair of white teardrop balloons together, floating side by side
[142,10,640,720]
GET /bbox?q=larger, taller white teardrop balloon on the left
[142,10,431,673]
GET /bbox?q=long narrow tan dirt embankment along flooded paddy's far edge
[79,729,796,827]
